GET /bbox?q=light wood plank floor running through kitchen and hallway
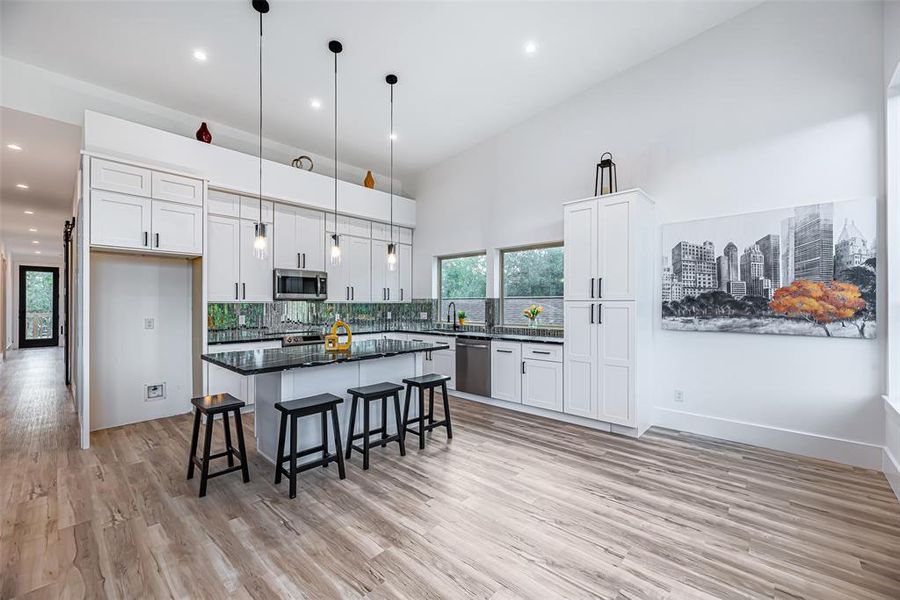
[0,349,900,600]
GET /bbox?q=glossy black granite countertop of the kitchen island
[201,340,450,375]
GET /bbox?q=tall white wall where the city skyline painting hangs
[413,3,885,467]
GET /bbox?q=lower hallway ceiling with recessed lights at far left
[0,108,81,261]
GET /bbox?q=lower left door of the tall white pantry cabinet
[563,302,598,419]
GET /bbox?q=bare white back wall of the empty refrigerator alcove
[90,252,192,431]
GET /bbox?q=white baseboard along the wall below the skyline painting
[653,407,884,471]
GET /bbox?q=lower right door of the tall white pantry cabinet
[597,302,635,427]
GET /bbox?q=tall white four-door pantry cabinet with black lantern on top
[563,189,657,435]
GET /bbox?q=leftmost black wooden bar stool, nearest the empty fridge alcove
[188,394,250,498]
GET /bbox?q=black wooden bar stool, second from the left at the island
[275,394,345,498]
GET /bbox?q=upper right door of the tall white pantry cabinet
[597,200,634,300]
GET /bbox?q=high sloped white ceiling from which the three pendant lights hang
[0,0,758,176]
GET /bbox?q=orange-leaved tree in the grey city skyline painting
[769,279,866,337]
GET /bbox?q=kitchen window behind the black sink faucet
[438,254,487,323]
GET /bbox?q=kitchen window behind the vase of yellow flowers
[500,244,563,327]
